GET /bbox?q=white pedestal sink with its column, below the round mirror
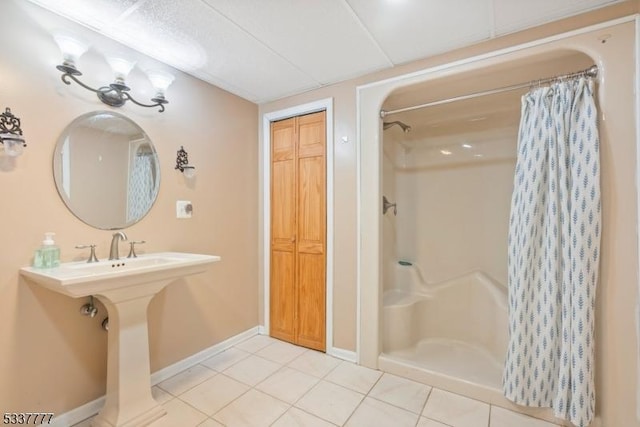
[20,252,220,427]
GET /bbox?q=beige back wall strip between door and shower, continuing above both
[259,0,640,351]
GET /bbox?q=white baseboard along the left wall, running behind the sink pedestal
[50,326,260,427]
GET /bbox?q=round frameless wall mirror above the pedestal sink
[53,111,160,230]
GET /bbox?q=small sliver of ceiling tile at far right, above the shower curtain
[493,0,618,35]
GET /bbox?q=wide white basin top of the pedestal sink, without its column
[20,252,220,298]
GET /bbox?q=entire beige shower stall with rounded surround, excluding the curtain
[358,17,637,425]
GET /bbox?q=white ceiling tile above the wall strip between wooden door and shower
[204,0,392,84]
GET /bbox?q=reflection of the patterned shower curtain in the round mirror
[127,154,155,222]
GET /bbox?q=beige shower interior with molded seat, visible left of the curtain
[381,89,526,389]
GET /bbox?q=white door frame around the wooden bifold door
[260,98,336,355]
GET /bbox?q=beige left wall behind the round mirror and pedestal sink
[0,0,258,414]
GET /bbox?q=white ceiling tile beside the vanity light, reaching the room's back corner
[107,0,318,102]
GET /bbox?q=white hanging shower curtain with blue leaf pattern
[503,78,601,427]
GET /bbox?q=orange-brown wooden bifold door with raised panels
[269,111,326,351]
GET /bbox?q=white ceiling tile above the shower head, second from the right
[347,0,492,64]
